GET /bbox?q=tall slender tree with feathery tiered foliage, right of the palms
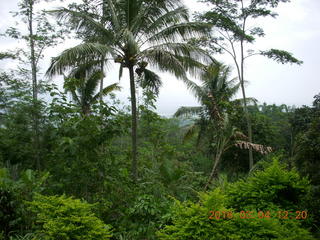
[198,0,302,169]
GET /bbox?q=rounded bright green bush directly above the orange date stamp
[227,160,311,211]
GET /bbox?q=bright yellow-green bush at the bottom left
[30,195,112,240]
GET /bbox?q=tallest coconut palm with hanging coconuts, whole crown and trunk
[48,0,210,179]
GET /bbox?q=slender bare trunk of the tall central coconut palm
[129,65,138,181]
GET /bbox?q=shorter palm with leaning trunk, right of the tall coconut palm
[175,63,244,189]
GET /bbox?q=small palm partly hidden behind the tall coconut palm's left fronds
[64,62,120,116]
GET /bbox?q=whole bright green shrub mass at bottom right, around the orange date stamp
[157,161,314,240]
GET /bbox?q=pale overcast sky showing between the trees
[0,0,320,116]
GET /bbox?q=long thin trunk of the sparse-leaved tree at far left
[28,0,41,170]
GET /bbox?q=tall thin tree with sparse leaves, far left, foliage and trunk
[5,0,65,169]
